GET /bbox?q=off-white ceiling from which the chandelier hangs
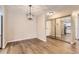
[7,5,79,16]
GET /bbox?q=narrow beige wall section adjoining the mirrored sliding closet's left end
[37,15,46,41]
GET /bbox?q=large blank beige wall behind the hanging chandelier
[4,6,37,42]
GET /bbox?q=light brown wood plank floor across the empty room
[0,38,79,54]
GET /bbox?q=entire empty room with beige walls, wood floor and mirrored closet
[0,5,79,54]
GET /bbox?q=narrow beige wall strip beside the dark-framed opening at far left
[2,6,8,48]
